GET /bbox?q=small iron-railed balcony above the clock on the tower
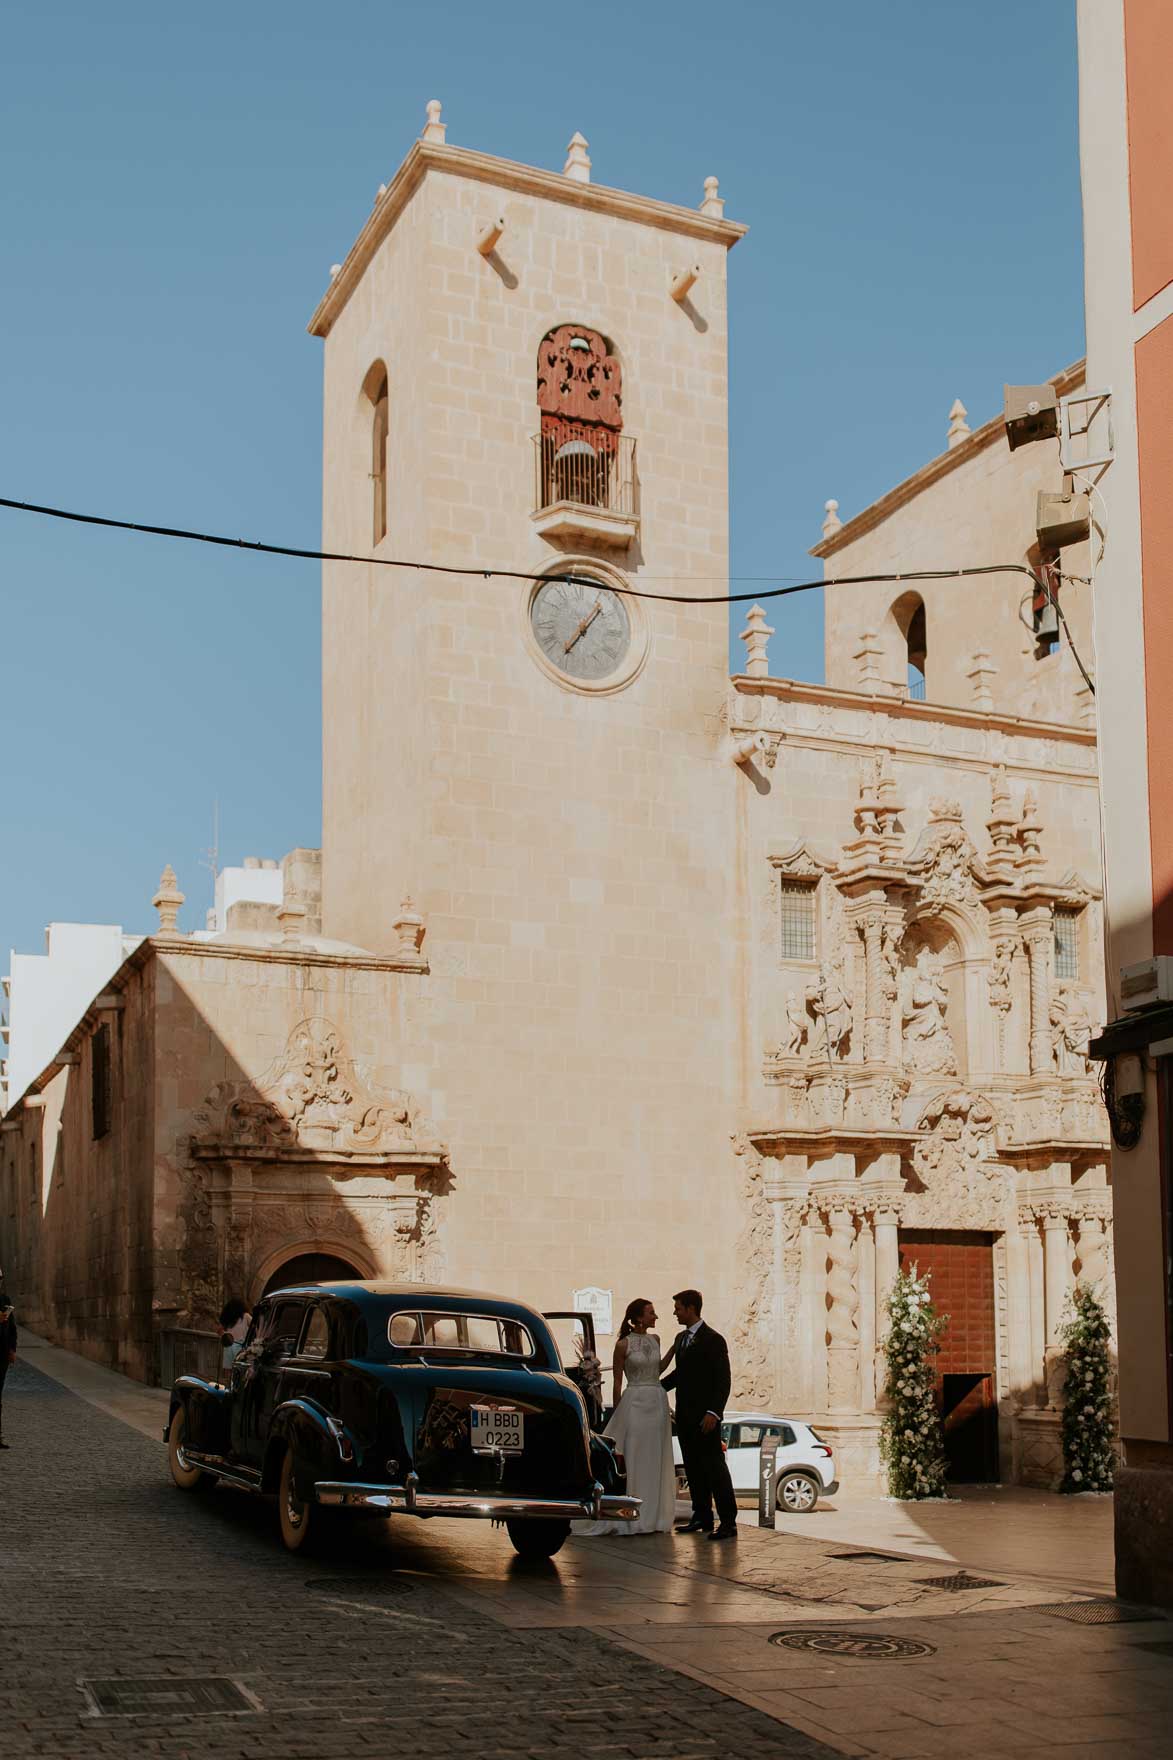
[530,433,639,546]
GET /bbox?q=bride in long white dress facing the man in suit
[571,1297,676,1536]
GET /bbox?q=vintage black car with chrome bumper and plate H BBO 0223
[166,1283,639,1558]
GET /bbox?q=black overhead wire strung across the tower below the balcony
[0,495,1042,608]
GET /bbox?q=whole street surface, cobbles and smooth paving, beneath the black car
[0,1346,1173,1760]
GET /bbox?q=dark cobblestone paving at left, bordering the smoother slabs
[0,1360,835,1760]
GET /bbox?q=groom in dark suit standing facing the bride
[660,1290,738,1540]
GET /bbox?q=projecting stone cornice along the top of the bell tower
[306,141,749,336]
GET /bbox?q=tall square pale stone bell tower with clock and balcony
[310,102,745,1302]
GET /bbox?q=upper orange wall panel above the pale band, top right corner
[1124,0,1173,308]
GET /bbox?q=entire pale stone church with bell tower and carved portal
[0,106,1111,1484]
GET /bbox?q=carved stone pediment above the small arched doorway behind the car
[192,1016,447,1167]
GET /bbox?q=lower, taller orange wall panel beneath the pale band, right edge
[1136,319,1173,954]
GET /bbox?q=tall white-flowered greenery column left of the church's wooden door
[881,1265,949,1498]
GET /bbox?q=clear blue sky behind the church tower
[0,0,1083,959]
